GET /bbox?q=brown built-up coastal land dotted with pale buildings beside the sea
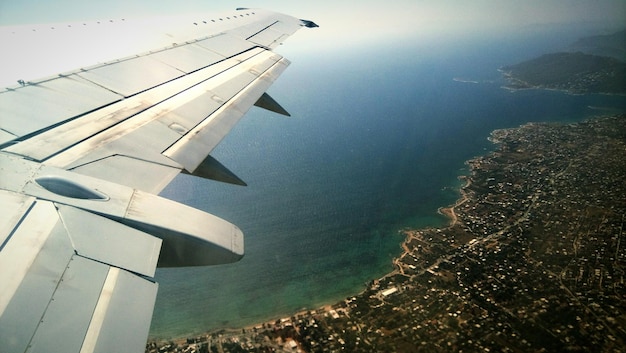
[146,115,626,353]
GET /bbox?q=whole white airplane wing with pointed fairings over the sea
[0,9,316,352]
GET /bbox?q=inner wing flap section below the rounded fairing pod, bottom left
[0,195,161,352]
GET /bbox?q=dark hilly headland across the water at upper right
[500,31,626,94]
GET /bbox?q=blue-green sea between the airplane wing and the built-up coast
[150,26,626,339]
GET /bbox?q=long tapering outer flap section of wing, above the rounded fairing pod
[6,48,289,193]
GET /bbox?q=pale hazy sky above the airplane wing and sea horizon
[0,0,626,36]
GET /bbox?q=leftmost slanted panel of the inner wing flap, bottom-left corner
[0,201,73,352]
